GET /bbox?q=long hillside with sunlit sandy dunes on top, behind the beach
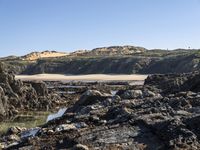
[1,46,200,74]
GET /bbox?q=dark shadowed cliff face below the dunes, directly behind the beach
[16,55,200,74]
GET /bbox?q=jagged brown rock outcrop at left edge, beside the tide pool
[0,63,59,121]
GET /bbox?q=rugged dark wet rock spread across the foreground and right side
[0,73,200,150]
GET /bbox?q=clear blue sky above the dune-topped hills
[0,0,200,56]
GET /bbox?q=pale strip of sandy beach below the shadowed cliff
[16,74,147,81]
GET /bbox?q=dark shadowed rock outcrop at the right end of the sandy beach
[144,71,200,93]
